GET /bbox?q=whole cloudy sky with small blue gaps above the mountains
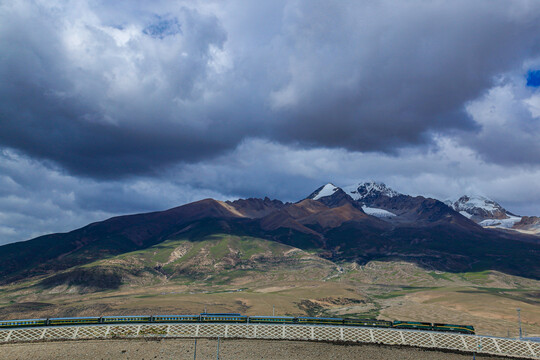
[0,0,540,244]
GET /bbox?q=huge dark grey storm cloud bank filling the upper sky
[0,1,540,178]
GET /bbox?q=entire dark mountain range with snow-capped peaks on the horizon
[0,182,540,283]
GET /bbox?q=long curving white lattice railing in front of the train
[0,323,540,359]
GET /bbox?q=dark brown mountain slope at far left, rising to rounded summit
[0,199,243,281]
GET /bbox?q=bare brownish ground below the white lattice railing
[0,339,524,360]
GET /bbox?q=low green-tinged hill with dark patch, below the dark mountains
[39,234,336,291]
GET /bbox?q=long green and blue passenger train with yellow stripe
[0,313,475,335]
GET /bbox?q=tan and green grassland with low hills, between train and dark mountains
[0,235,540,336]
